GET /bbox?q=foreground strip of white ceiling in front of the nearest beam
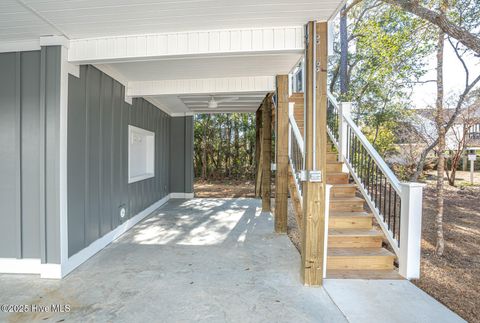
[0,0,342,41]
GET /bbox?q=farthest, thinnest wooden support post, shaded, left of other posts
[262,95,272,212]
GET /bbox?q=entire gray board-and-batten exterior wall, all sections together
[0,53,193,264]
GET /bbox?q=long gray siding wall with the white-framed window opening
[68,66,173,256]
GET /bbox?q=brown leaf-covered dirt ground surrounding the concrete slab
[195,172,480,322]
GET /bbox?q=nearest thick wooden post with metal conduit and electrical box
[301,22,328,285]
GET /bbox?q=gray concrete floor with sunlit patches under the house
[0,199,459,323]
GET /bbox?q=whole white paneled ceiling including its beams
[0,0,345,115]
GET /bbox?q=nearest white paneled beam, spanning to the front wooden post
[68,26,304,64]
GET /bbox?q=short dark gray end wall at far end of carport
[170,116,194,193]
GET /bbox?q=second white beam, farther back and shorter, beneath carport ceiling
[127,76,275,97]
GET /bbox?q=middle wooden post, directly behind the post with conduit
[275,75,288,233]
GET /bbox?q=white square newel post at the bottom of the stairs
[399,183,425,279]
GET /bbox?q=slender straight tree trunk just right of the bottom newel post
[435,25,445,256]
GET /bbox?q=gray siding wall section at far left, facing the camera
[0,46,60,263]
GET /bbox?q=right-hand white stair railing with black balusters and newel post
[327,93,424,279]
